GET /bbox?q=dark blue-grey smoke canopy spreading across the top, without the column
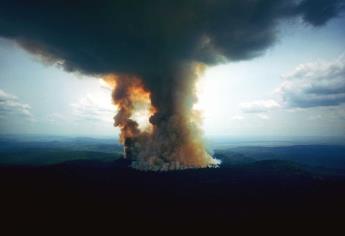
[0,0,344,75]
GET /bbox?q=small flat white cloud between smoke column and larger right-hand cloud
[240,99,280,113]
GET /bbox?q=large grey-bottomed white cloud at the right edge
[276,56,345,108]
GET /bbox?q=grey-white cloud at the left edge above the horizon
[0,89,33,120]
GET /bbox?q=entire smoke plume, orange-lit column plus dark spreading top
[0,0,344,170]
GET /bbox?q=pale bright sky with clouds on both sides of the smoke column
[0,9,345,138]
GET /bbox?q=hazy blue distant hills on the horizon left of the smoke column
[0,138,122,166]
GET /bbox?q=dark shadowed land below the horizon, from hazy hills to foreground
[0,138,345,228]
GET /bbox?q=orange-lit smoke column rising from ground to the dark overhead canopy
[106,63,219,171]
